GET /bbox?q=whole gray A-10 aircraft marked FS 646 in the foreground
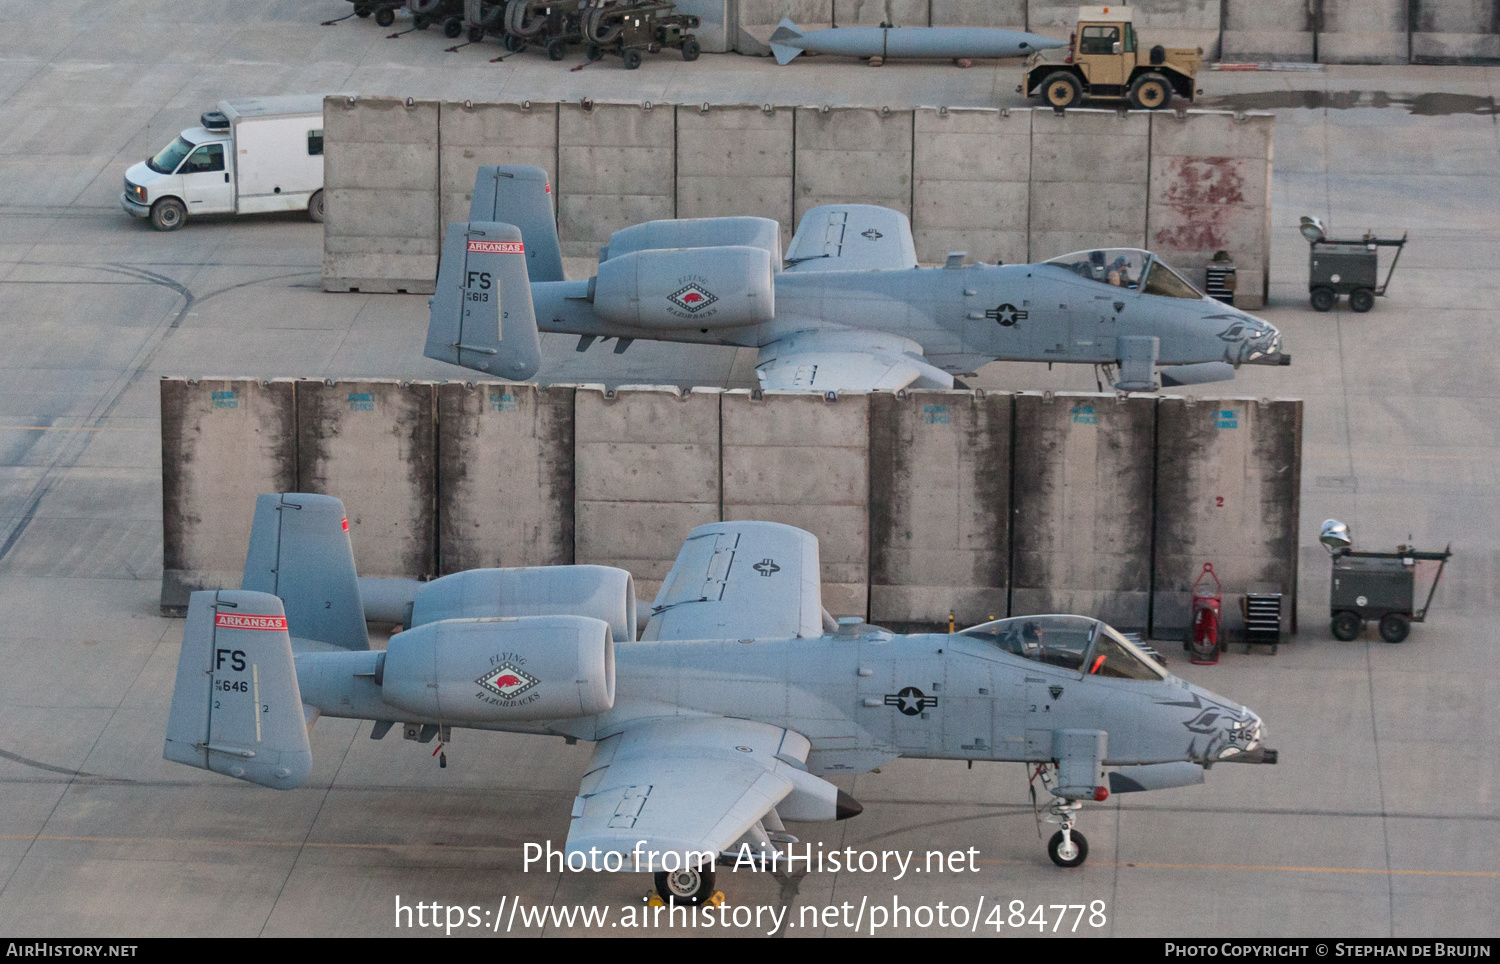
[164,495,1277,903]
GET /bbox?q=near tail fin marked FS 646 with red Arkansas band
[162,589,312,790]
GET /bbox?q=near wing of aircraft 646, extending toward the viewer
[567,717,833,871]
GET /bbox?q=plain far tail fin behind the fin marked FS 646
[240,492,371,649]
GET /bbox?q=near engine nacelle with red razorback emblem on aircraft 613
[590,244,776,328]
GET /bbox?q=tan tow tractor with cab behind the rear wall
[1016,6,1203,111]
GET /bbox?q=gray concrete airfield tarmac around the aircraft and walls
[0,0,1500,937]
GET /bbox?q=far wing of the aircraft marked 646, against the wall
[641,522,824,640]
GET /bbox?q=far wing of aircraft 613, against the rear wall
[786,204,917,271]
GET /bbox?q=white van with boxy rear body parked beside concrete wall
[120,94,323,231]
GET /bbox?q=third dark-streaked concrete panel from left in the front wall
[438,382,573,574]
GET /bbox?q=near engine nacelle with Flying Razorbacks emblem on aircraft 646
[378,616,615,723]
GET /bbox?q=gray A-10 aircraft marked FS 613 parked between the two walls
[425,166,1290,391]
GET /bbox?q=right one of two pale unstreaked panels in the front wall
[722,391,870,616]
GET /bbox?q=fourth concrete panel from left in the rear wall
[677,106,797,247]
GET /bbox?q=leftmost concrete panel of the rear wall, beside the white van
[323,96,440,294]
